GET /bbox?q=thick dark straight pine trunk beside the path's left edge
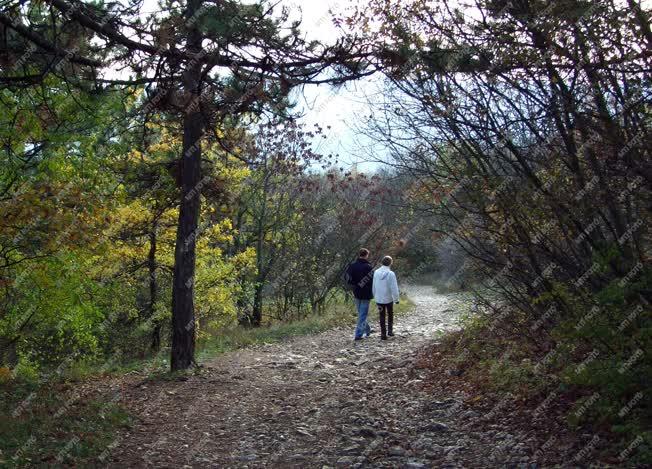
[170,0,203,371]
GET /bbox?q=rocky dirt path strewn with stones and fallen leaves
[104,287,527,468]
